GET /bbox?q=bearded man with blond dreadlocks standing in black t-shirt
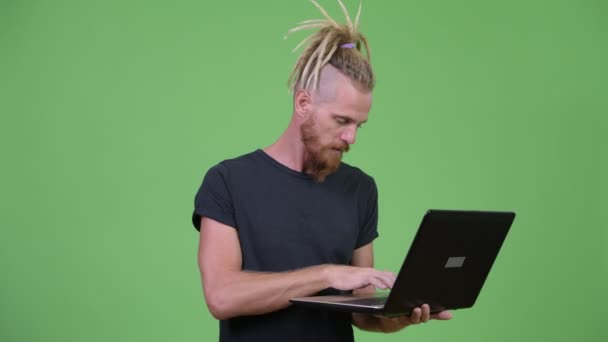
[193,0,451,341]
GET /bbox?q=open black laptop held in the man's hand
[291,210,515,316]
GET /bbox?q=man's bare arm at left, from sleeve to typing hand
[198,217,392,319]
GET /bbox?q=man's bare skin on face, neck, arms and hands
[198,65,452,332]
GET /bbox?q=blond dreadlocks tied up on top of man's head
[285,0,376,94]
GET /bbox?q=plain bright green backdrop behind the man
[0,0,608,341]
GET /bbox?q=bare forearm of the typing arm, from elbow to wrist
[203,265,329,319]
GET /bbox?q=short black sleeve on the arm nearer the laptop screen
[355,177,378,248]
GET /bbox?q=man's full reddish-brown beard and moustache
[300,116,350,183]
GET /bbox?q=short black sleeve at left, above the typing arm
[192,164,236,230]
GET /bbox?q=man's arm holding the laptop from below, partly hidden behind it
[352,243,452,333]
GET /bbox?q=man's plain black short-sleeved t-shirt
[192,150,378,342]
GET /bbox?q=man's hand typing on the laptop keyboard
[325,265,396,291]
